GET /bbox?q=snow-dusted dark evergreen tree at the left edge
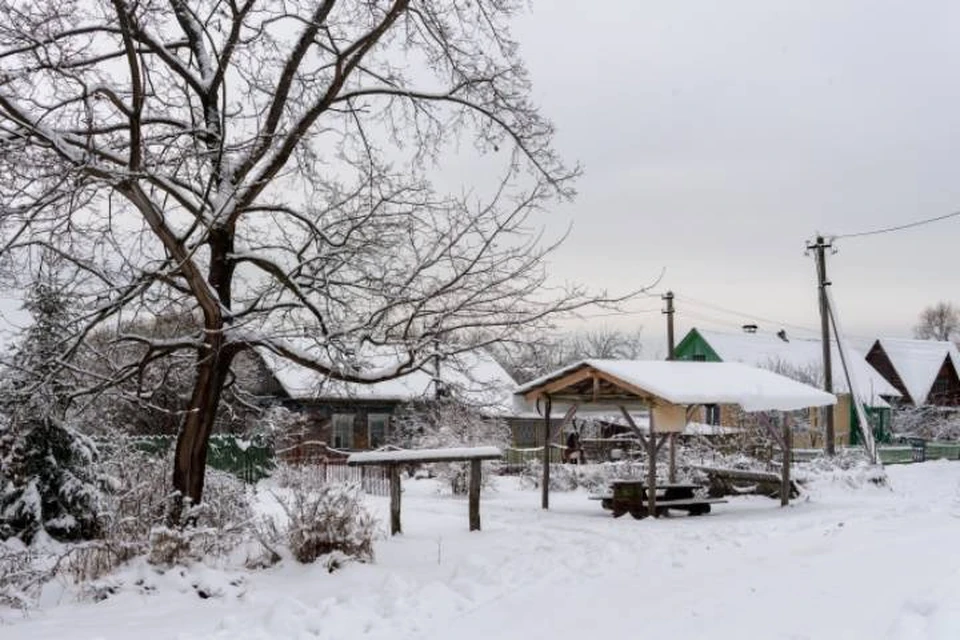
[0,275,100,544]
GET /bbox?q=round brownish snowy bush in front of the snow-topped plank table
[261,483,378,571]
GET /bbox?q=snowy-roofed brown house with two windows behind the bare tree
[259,350,516,451]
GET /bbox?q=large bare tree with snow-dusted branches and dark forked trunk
[0,0,632,510]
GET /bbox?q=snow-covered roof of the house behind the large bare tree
[259,349,517,416]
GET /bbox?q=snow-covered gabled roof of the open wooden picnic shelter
[517,360,837,411]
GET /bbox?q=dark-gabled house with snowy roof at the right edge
[867,338,960,407]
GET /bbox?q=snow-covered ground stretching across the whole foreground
[0,462,960,640]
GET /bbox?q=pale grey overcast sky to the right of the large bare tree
[502,0,960,355]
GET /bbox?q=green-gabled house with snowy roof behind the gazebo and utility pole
[675,328,901,446]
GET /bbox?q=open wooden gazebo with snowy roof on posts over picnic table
[517,360,837,514]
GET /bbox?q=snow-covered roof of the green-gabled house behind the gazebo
[696,329,901,407]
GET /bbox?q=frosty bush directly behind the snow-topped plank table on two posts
[392,398,511,495]
